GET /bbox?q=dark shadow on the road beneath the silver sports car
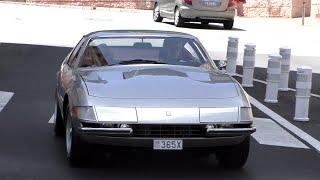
[52,138,248,179]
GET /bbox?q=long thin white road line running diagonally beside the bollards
[250,96,320,152]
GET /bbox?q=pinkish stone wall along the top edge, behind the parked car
[0,0,320,18]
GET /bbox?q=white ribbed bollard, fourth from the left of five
[279,47,291,91]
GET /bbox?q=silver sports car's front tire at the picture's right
[216,137,250,169]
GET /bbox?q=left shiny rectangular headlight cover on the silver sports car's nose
[96,107,138,123]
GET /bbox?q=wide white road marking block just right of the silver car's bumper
[252,118,309,149]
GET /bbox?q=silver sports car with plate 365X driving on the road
[55,30,255,168]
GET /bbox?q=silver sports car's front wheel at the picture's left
[65,106,88,166]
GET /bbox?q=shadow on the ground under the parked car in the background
[163,22,246,31]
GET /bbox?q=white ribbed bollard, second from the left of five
[242,44,256,87]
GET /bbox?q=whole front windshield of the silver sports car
[79,37,216,69]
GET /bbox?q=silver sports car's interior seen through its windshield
[79,38,203,67]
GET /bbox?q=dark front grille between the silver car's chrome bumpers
[131,125,205,138]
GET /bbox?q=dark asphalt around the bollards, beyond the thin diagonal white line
[236,66,320,139]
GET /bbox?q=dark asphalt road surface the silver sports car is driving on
[0,44,320,180]
